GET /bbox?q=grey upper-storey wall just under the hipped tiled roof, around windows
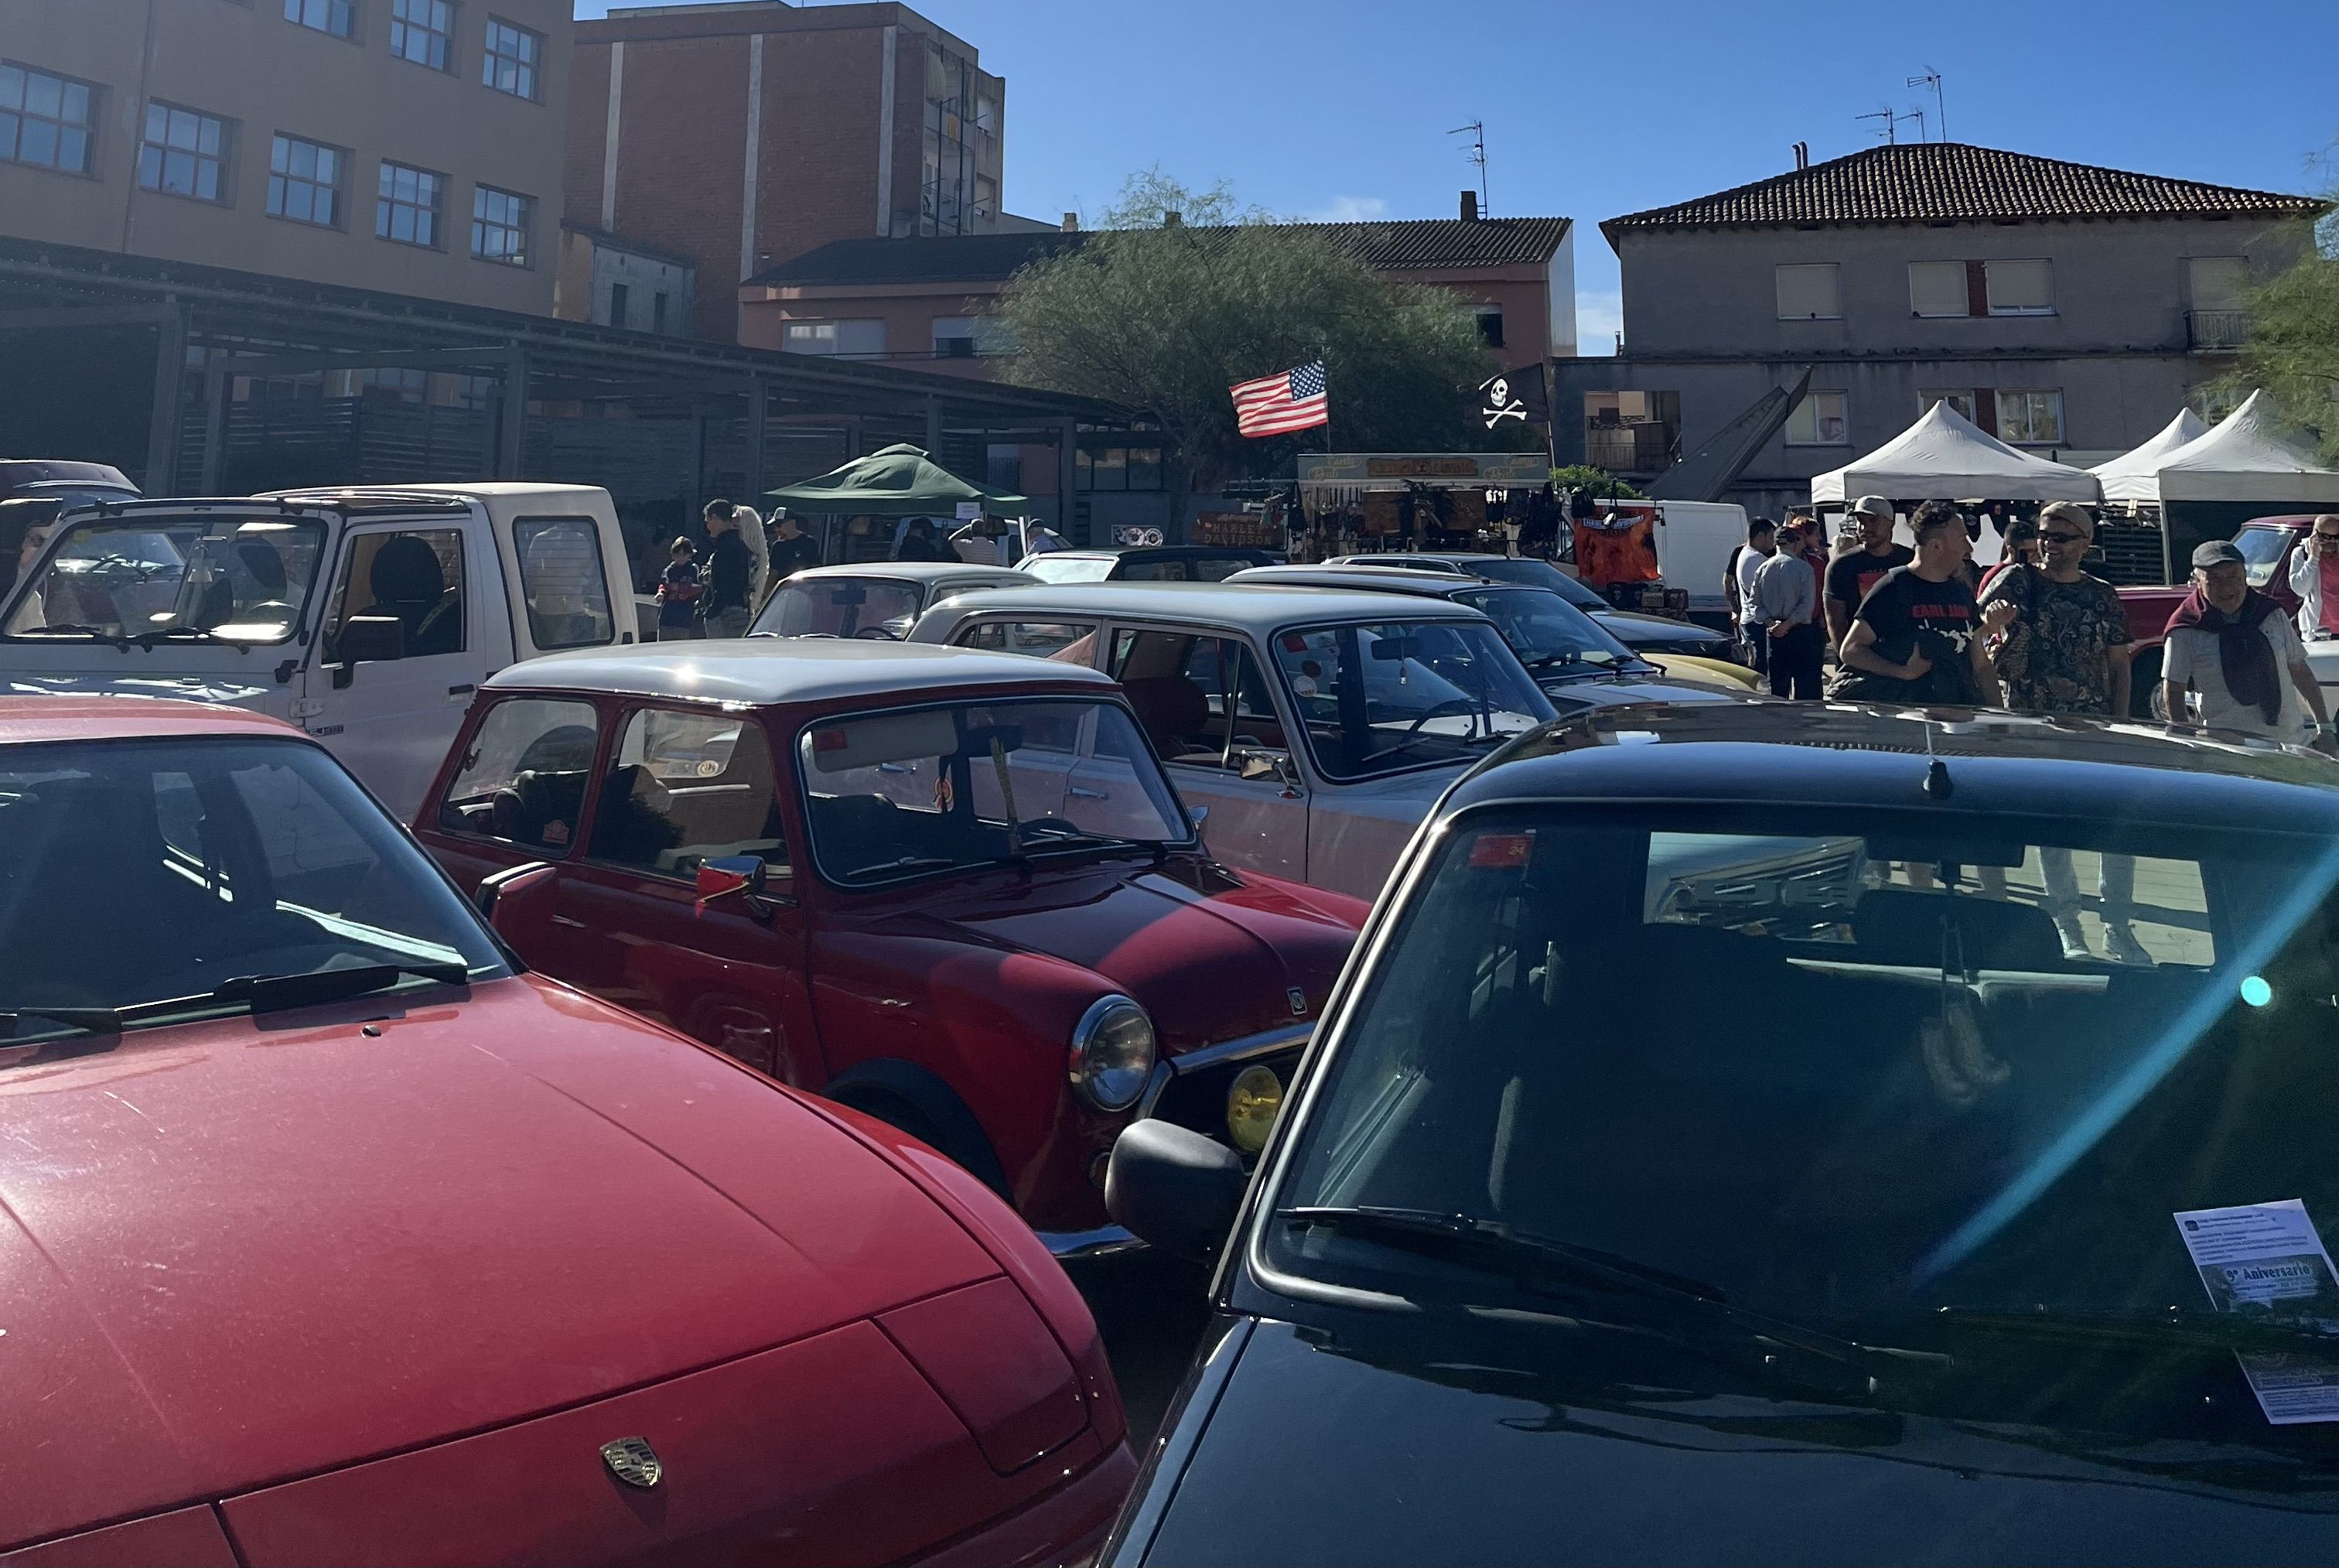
[1619,220,2295,358]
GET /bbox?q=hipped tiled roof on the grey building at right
[1600,143,2327,246]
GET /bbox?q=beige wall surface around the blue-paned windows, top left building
[0,0,571,313]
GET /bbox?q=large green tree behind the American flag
[1001,169,1492,484]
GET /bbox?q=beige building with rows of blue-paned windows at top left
[0,0,571,313]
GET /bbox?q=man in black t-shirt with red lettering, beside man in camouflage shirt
[1843,500,2014,707]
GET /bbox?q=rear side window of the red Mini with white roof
[437,698,601,856]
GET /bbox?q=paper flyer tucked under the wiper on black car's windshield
[2175,1198,2339,1425]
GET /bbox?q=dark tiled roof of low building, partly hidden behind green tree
[749,217,1572,285]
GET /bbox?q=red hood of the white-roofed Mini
[903,863,1364,1053]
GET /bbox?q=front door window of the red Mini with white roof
[587,707,788,880]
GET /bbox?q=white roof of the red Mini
[482,637,1113,705]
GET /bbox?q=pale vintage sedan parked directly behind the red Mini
[910,582,1553,899]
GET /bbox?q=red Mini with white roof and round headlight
[416,639,1366,1255]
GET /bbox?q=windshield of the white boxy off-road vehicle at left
[7,513,325,644]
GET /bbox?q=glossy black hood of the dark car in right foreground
[1118,1320,2339,1563]
